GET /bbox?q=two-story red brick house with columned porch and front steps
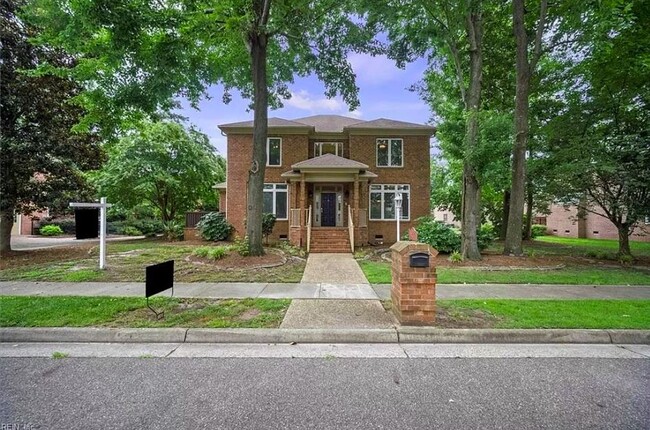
[215,115,435,252]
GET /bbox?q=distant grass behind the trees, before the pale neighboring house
[530,236,650,257]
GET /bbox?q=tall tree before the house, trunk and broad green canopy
[30,0,376,255]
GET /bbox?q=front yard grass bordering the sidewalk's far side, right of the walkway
[359,260,650,285]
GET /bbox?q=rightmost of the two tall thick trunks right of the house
[503,0,530,256]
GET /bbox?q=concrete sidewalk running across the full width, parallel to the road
[0,281,650,300]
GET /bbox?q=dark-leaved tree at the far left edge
[0,0,103,252]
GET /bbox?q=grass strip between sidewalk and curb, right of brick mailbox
[437,300,650,329]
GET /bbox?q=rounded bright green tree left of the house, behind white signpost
[94,122,225,222]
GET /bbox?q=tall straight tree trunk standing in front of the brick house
[246,31,268,255]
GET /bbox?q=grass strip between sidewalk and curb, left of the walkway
[0,296,291,328]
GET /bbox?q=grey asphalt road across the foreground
[0,356,650,429]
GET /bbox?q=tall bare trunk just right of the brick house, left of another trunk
[461,3,483,260]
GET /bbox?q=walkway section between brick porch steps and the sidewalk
[301,253,369,284]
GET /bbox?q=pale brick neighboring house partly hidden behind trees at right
[546,204,650,242]
